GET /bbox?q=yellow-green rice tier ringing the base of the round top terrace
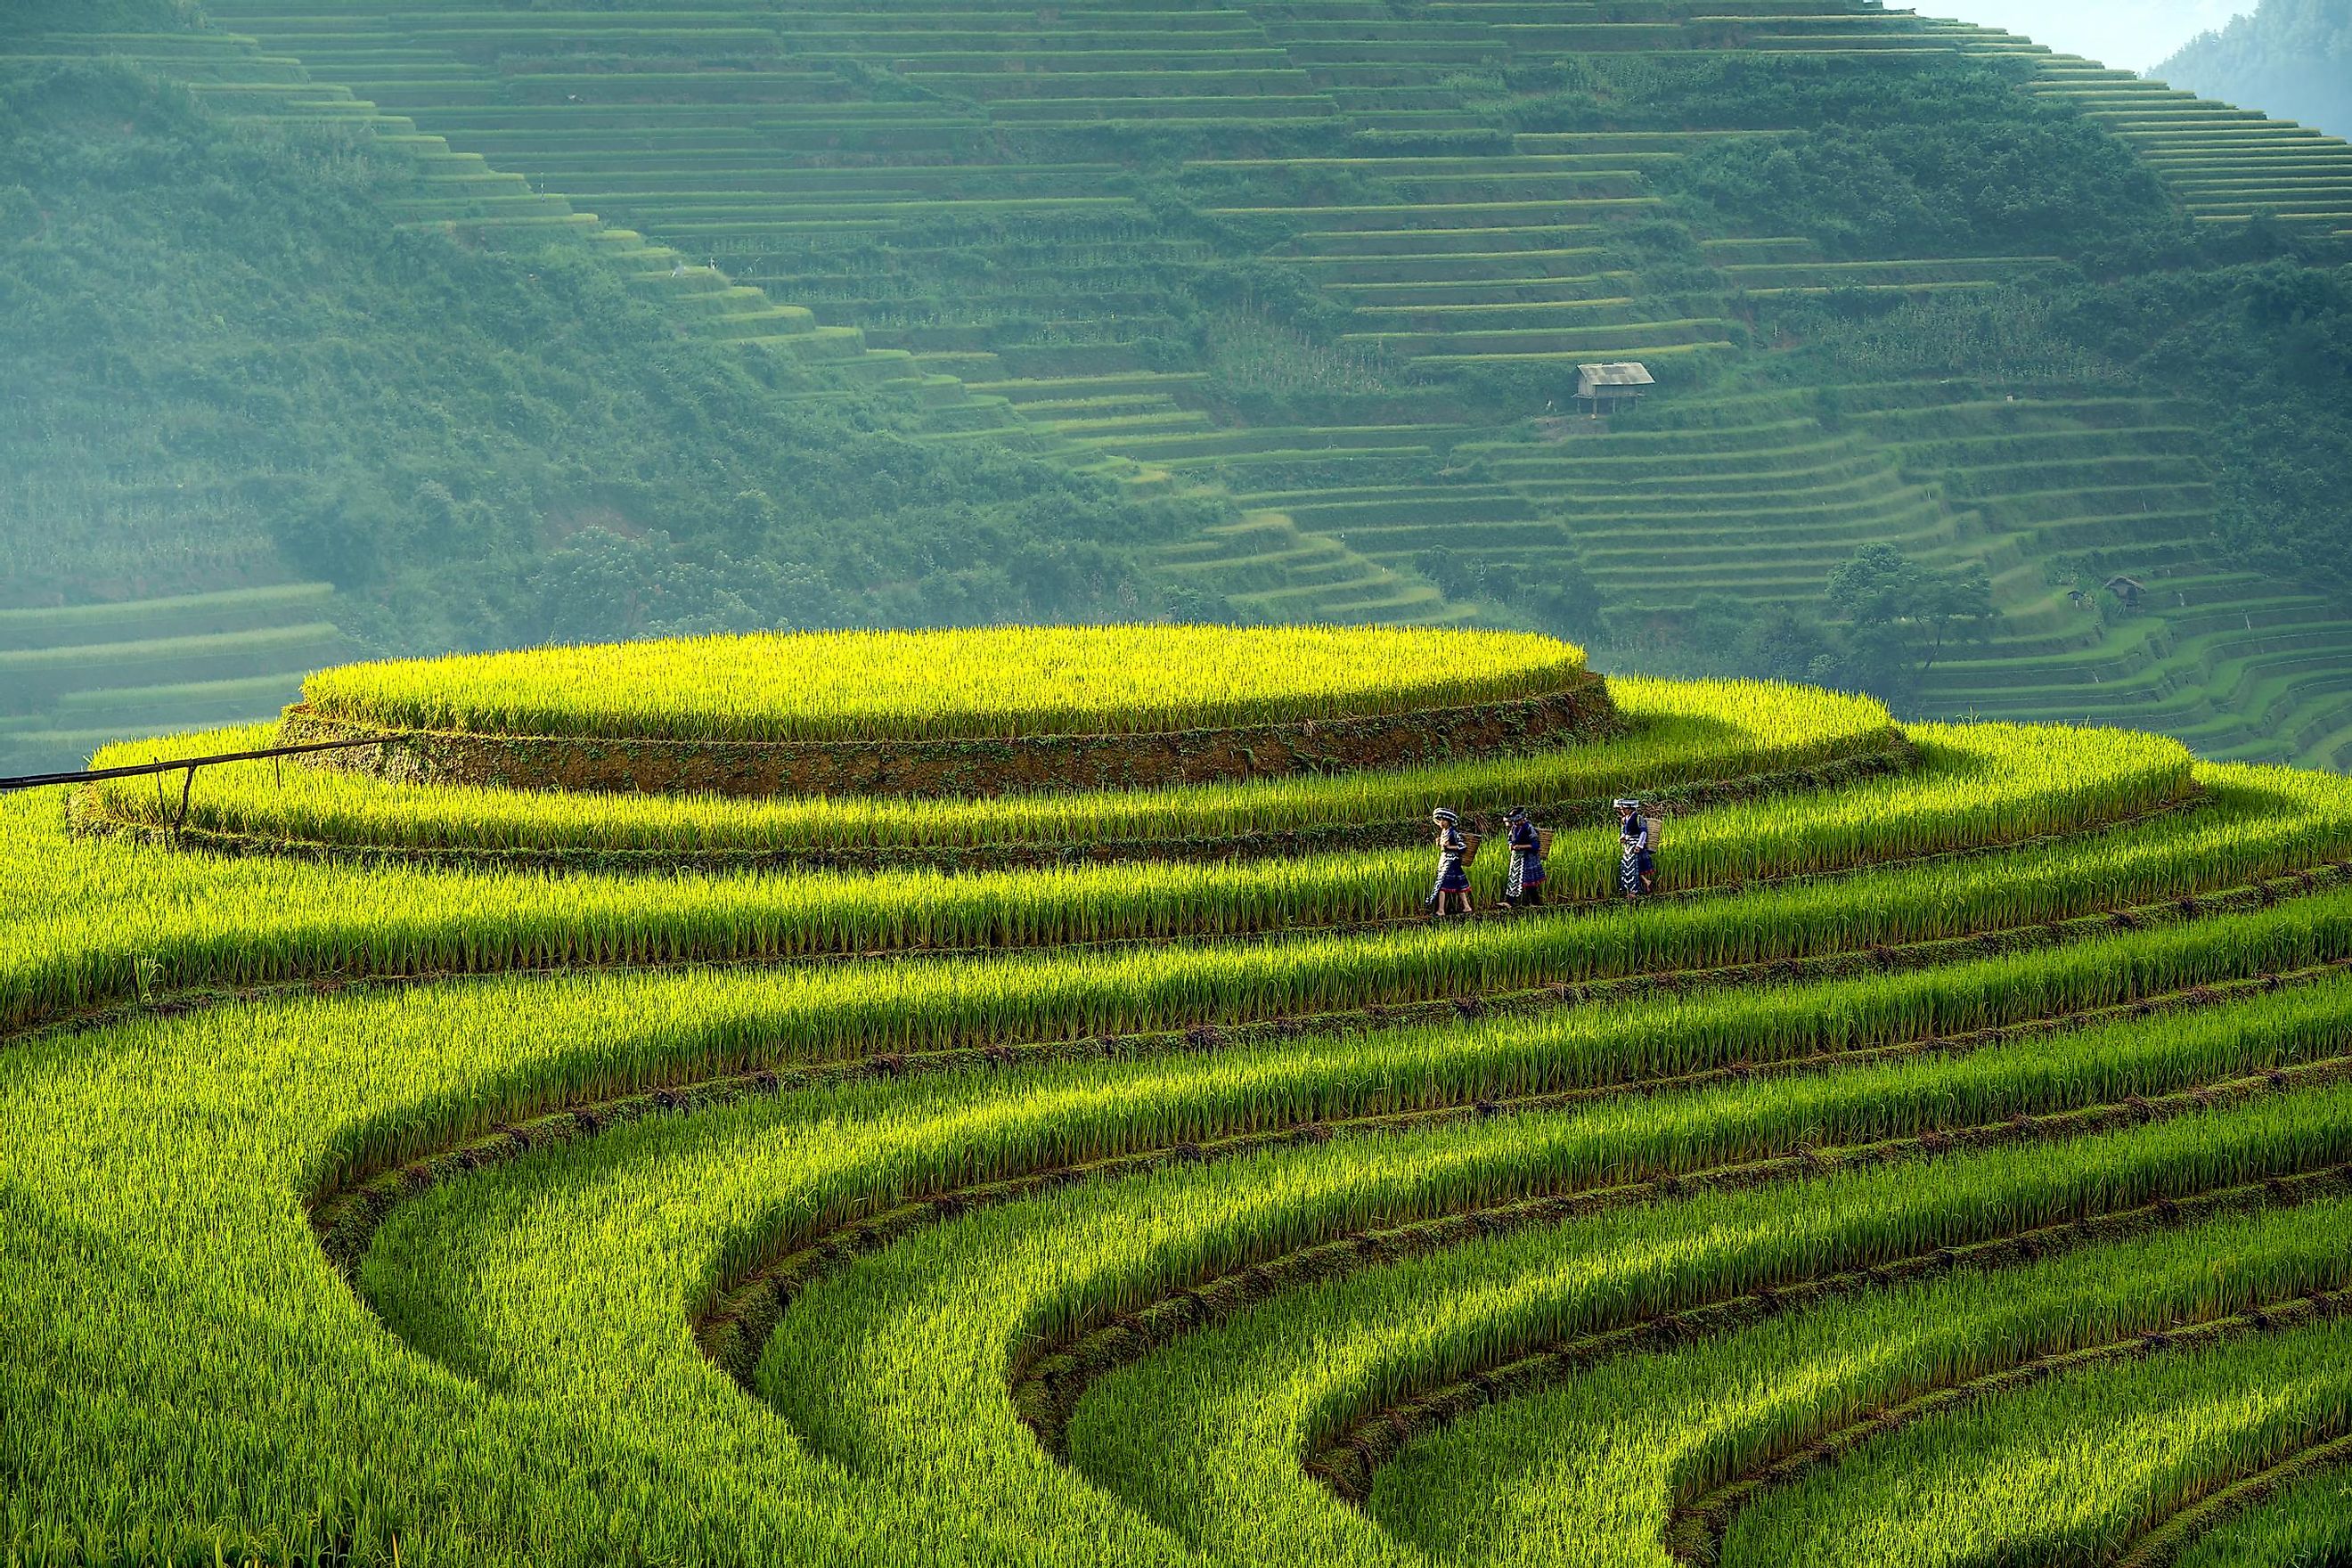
[78,677,1912,870]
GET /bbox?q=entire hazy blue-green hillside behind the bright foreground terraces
[7,0,2352,762]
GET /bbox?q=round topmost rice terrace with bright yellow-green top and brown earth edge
[280,625,1618,797]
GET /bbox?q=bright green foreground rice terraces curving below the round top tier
[13,634,2352,1568]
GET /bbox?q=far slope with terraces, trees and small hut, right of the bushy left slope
[142,0,2352,762]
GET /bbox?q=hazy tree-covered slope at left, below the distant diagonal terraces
[0,66,1213,649]
